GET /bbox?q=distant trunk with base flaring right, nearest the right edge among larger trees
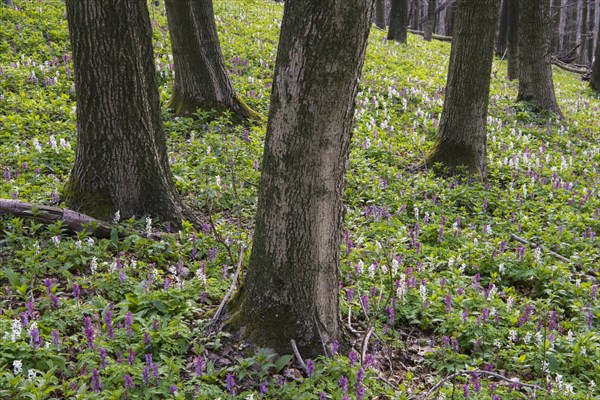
[517,0,563,118]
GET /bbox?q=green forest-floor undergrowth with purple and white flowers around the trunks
[0,0,600,399]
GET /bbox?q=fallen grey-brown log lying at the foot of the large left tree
[0,199,113,239]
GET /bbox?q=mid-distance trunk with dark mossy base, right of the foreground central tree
[426,0,500,178]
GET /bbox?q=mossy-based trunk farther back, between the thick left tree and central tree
[165,0,261,122]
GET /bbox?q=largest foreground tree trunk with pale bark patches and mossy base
[228,0,373,357]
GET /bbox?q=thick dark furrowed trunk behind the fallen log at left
[66,0,182,225]
